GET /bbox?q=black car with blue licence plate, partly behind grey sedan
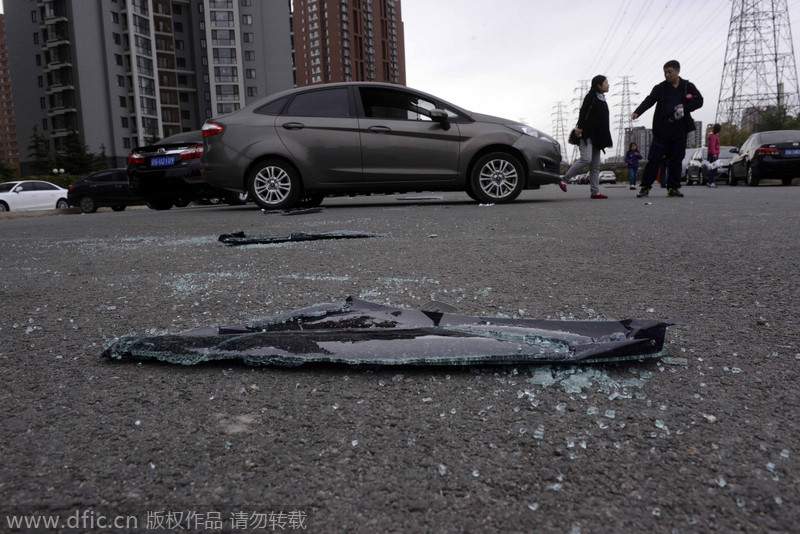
[128,130,247,210]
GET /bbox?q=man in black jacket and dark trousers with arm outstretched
[631,60,703,198]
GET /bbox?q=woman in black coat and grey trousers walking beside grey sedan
[564,74,612,198]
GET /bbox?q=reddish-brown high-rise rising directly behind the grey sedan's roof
[293,0,406,86]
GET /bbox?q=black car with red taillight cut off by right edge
[729,130,800,187]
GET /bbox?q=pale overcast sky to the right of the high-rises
[401,0,800,155]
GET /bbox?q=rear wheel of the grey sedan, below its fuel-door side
[247,159,302,210]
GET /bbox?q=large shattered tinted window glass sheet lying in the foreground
[103,297,675,366]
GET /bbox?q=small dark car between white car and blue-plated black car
[67,169,144,213]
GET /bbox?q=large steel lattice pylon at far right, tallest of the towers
[716,0,800,127]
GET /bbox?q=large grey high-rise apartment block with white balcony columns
[4,0,294,174]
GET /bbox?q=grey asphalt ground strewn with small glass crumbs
[0,181,800,533]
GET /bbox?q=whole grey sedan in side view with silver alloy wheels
[202,82,561,209]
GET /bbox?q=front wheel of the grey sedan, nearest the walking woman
[470,152,525,204]
